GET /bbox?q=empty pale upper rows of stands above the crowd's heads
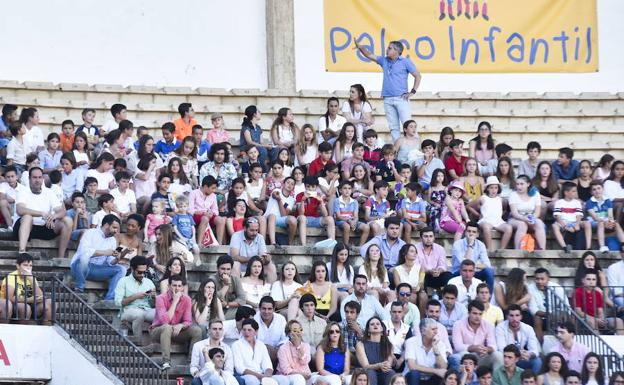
[0,81,624,160]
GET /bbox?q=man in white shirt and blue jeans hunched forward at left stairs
[69,214,126,300]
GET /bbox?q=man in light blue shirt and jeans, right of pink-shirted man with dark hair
[451,222,494,293]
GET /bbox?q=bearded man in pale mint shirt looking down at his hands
[115,255,156,344]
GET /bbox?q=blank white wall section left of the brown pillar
[0,0,266,88]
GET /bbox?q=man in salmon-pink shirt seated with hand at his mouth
[150,275,202,370]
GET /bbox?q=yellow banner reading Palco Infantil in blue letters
[324,0,598,73]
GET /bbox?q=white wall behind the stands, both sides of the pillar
[0,0,624,92]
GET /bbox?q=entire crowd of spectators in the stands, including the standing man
[0,38,624,385]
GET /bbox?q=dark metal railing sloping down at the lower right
[547,287,624,377]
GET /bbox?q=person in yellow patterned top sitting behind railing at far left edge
[0,253,52,321]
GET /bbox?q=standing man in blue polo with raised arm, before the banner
[355,40,422,142]
